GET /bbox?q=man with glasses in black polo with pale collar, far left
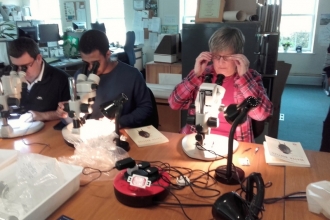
[8,37,70,122]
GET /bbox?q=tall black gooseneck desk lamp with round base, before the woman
[215,96,259,185]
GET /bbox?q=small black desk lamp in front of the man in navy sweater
[100,93,130,151]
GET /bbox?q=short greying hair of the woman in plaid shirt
[209,26,245,54]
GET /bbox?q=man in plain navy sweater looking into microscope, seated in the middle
[57,30,153,128]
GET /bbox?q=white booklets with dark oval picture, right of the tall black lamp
[264,136,311,167]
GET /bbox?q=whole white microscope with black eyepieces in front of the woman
[182,74,238,160]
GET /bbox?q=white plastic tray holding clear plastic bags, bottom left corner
[0,159,83,220]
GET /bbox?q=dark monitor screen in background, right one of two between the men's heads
[38,24,61,43]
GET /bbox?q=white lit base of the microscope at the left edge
[0,120,44,138]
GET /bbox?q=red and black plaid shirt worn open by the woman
[168,65,273,142]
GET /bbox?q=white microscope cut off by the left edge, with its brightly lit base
[0,68,44,138]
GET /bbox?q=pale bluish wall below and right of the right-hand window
[277,0,330,85]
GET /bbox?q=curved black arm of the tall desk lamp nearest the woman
[226,109,247,179]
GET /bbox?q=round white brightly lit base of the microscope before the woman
[182,134,238,160]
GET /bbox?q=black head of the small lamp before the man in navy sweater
[100,93,128,119]
